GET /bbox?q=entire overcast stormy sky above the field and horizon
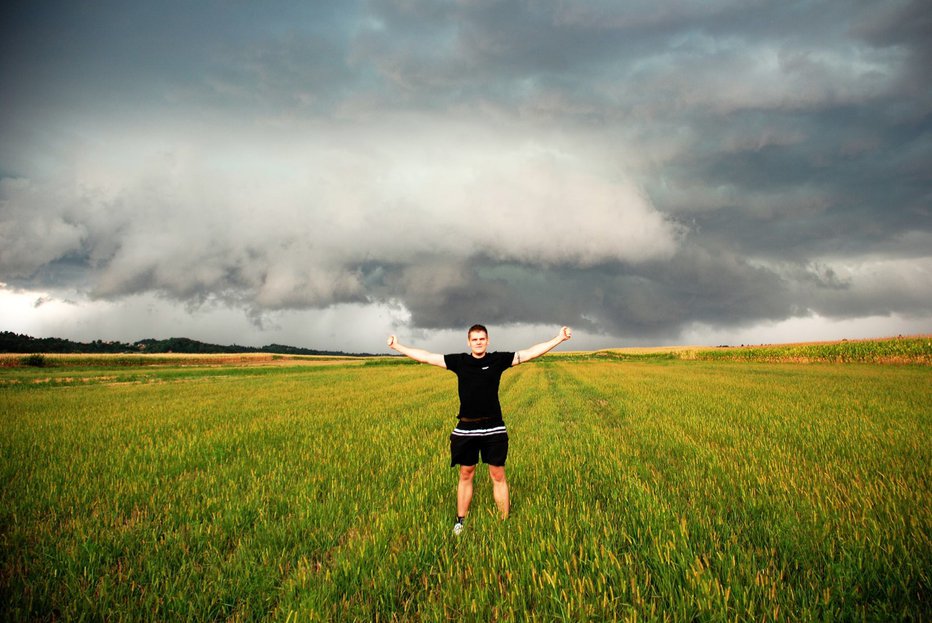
[0,0,932,352]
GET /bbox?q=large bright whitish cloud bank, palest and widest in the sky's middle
[0,122,681,309]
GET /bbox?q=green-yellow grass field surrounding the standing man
[0,348,932,621]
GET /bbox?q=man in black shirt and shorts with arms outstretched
[388,324,573,534]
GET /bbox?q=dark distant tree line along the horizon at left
[0,331,368,356]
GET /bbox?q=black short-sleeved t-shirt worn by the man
[443,352,515,420]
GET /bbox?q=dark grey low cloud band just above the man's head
[382,251,794,338]
